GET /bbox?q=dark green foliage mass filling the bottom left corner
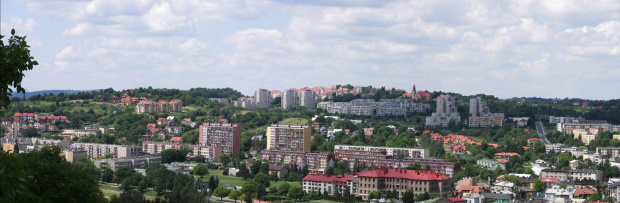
[0,147,105,202]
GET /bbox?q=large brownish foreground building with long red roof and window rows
[352,168,452,200]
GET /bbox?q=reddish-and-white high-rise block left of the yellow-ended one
[198,123,241,157]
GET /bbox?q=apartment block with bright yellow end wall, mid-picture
[266,124,312,152]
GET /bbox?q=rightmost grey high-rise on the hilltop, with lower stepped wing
[469,97,504,128]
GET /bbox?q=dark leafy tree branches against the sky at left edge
[0,29,39,113]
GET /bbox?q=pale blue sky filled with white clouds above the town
[0,0,620,99]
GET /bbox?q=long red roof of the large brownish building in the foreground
[356,168,450,181]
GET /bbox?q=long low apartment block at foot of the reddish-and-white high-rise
[142,142,222,162]
